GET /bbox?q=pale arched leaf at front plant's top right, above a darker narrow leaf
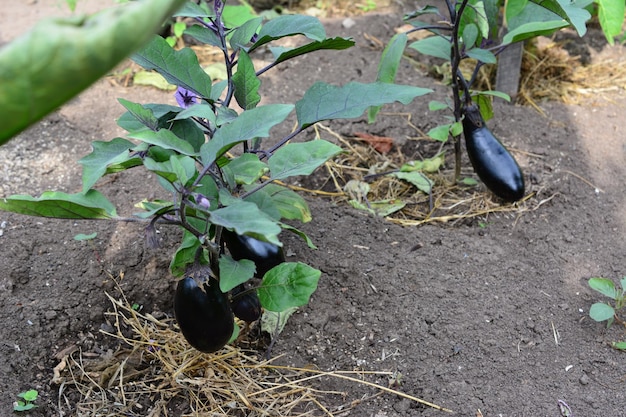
[248,15,326,52]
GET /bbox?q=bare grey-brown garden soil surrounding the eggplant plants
[0,0,626,417]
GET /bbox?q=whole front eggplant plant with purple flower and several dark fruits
[0,0,431,352]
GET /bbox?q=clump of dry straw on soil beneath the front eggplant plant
[53,280,450,417]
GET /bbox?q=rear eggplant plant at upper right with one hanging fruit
[369,0,596,201]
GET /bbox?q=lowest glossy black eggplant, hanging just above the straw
[174,277,234,353]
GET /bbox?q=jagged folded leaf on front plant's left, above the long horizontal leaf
[78,138,142,192]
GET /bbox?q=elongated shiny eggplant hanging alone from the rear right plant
[463,105,524,201]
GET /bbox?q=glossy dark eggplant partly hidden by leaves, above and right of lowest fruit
[222,229,285,278]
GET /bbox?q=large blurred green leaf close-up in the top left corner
[0,0,184,144]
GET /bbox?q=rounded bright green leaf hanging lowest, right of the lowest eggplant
[258,262,322,312]
